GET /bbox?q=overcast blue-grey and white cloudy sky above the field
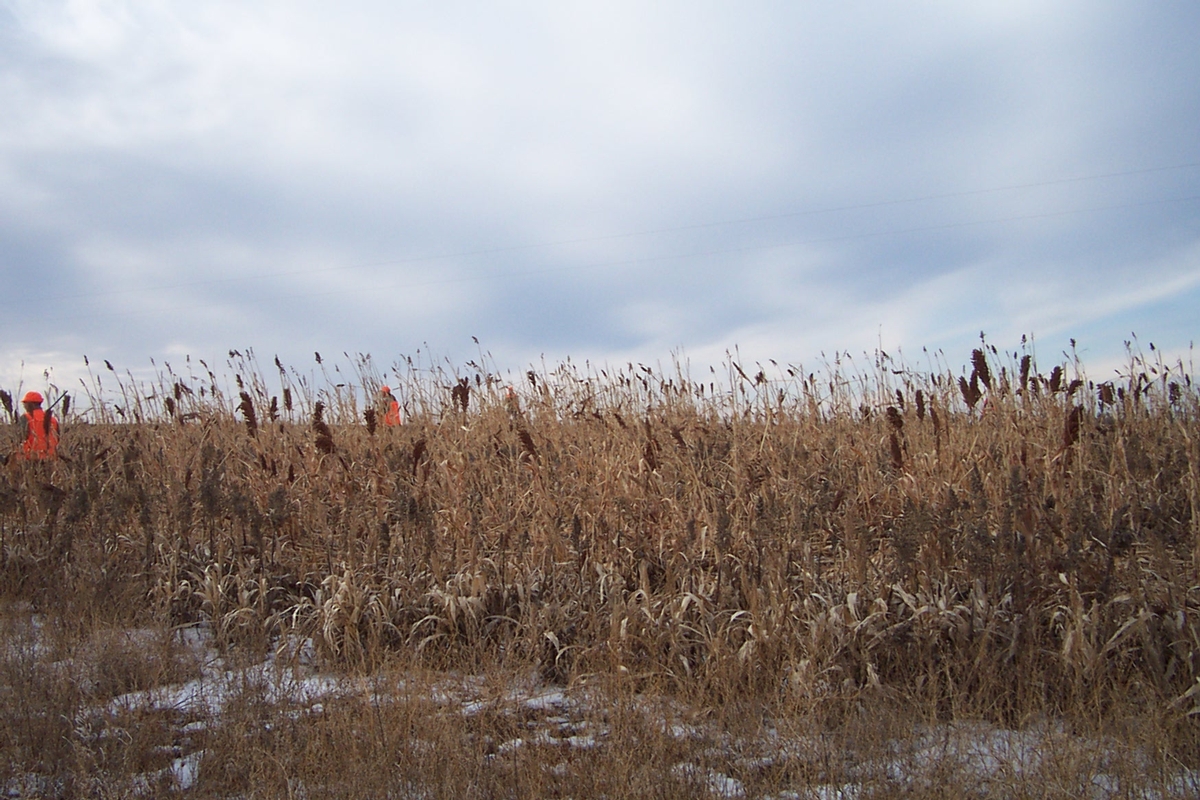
[0,0,1200,398]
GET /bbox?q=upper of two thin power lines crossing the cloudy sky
[7,162,1200,307]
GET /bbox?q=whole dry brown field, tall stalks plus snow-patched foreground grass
[0,345,1200,798]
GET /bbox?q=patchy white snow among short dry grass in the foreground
[4,624,1200,800]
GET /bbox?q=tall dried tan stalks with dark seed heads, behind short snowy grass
[0,347,1200,753]
